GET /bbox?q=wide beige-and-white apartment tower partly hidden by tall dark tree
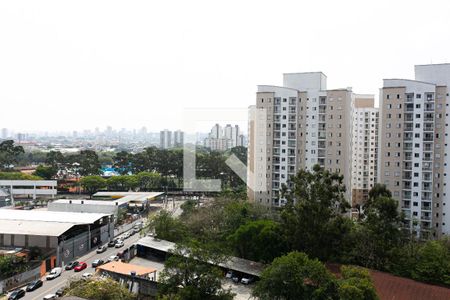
[247,72,354,206]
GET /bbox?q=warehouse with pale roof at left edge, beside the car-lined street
[0,209,114,265]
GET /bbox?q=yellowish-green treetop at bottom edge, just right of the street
[64,279,136,300]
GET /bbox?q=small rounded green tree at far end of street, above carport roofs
[145,210,186,242]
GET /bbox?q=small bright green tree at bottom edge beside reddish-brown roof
[338,266,379,300]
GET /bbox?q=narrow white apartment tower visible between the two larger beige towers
[351,95,379,206]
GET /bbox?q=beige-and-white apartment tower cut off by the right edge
[379,64,450,238]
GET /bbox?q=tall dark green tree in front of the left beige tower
[281,165,351,259]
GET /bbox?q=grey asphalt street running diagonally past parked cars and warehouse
[17,227,140,300]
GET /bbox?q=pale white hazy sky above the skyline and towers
[0,0,450,131]
